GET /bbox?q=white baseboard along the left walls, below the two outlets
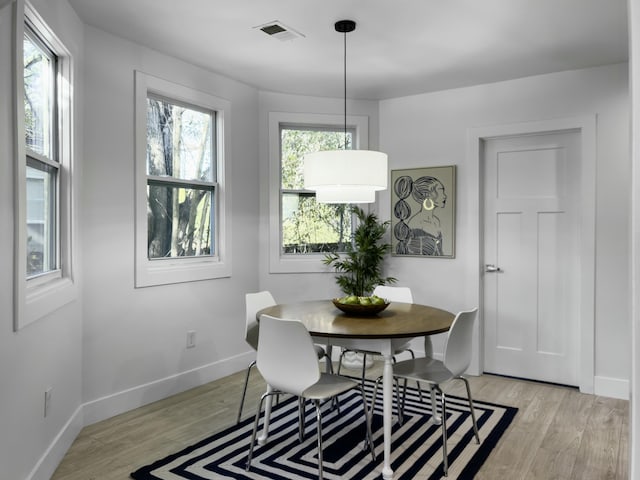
[25,352,255,480]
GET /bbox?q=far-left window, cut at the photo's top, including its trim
[14,2,76,330]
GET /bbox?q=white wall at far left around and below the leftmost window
[0,0,83,479]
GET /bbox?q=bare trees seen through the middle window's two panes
[146,96,216,259]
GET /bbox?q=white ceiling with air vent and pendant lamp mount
[69,0,628,99]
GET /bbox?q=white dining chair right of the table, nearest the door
[373,308,480,477]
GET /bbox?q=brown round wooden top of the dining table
[256,300,455,338]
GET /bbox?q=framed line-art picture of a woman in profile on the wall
[391,165,456,258]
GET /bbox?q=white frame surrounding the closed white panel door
[466,114,596,393]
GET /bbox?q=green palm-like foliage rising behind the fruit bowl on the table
[323,206,396,297]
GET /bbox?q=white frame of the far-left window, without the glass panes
[13,0,77,332]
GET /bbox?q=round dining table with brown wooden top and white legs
[256,300,455,480]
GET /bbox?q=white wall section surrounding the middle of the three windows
[82,27,259,422]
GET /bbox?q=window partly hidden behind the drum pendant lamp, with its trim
[269,112,368,273]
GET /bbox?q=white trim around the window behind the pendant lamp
[268,112,369,273]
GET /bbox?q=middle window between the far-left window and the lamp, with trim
[136,72,230,287]
